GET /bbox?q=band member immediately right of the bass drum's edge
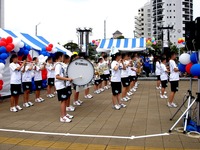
[93,63,101,94]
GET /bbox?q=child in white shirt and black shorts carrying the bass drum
[55,52,73,123]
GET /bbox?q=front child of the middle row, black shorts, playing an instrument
[111,53,126,110]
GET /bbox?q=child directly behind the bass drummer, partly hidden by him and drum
[63,55,75,111]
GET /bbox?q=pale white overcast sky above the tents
[5,0,200,44]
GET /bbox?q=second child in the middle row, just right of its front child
[120,54,130,101]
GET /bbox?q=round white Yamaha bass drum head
[67,59,94,85]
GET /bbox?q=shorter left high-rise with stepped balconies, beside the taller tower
[134,2,151,38]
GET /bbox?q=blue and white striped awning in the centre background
[97,38,146,53]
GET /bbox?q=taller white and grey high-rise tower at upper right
[151,0,193,47]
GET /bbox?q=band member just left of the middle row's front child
[103,55,110,90]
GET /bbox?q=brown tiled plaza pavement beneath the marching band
[0,81,200,150]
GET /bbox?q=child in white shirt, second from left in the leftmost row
[21,56,33,107]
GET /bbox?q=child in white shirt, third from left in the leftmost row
[33,57,45,103]
